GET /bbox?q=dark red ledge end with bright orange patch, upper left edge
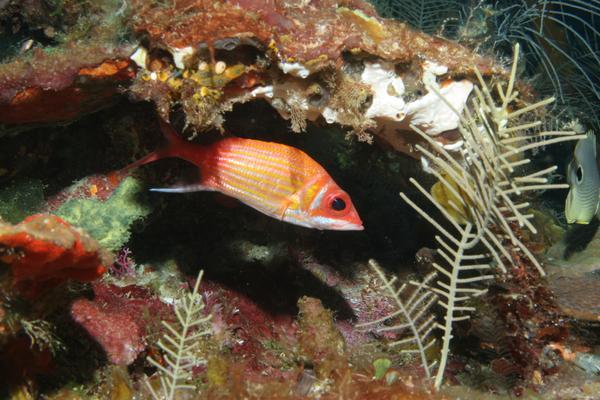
[0,45,135,127]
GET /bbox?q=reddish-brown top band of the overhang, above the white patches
[132,0,502,77]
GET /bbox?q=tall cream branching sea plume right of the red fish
[360,44,585,388]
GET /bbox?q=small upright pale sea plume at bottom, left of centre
[146,271,212,400]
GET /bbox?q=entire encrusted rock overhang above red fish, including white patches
[0,0,507,157]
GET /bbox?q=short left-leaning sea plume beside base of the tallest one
[357,260,437,378]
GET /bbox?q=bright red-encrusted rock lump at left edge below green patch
[0,214,112,296]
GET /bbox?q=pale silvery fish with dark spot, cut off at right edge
[565,131,600,224]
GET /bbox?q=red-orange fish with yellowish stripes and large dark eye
[124,121,363,230]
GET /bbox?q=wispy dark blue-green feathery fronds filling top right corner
[371,0,600,125]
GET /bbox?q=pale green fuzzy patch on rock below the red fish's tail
[55,177,151,251]
